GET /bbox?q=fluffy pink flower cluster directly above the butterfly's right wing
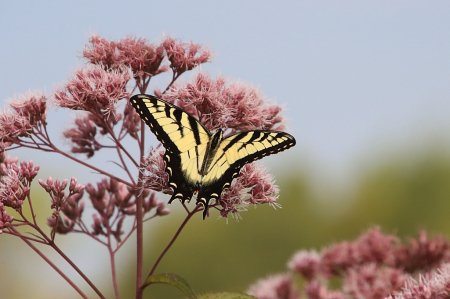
[163,73,284,134]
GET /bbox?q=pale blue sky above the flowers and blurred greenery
[0,0,450,182]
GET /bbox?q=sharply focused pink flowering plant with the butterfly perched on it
[0,35,286,298]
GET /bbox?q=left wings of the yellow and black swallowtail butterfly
[130,94,211,202]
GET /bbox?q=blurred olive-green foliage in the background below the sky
[4,147,450,298]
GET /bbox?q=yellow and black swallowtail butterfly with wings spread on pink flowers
[130,94,295,218]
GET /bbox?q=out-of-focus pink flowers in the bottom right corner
[248,227,450,299]
